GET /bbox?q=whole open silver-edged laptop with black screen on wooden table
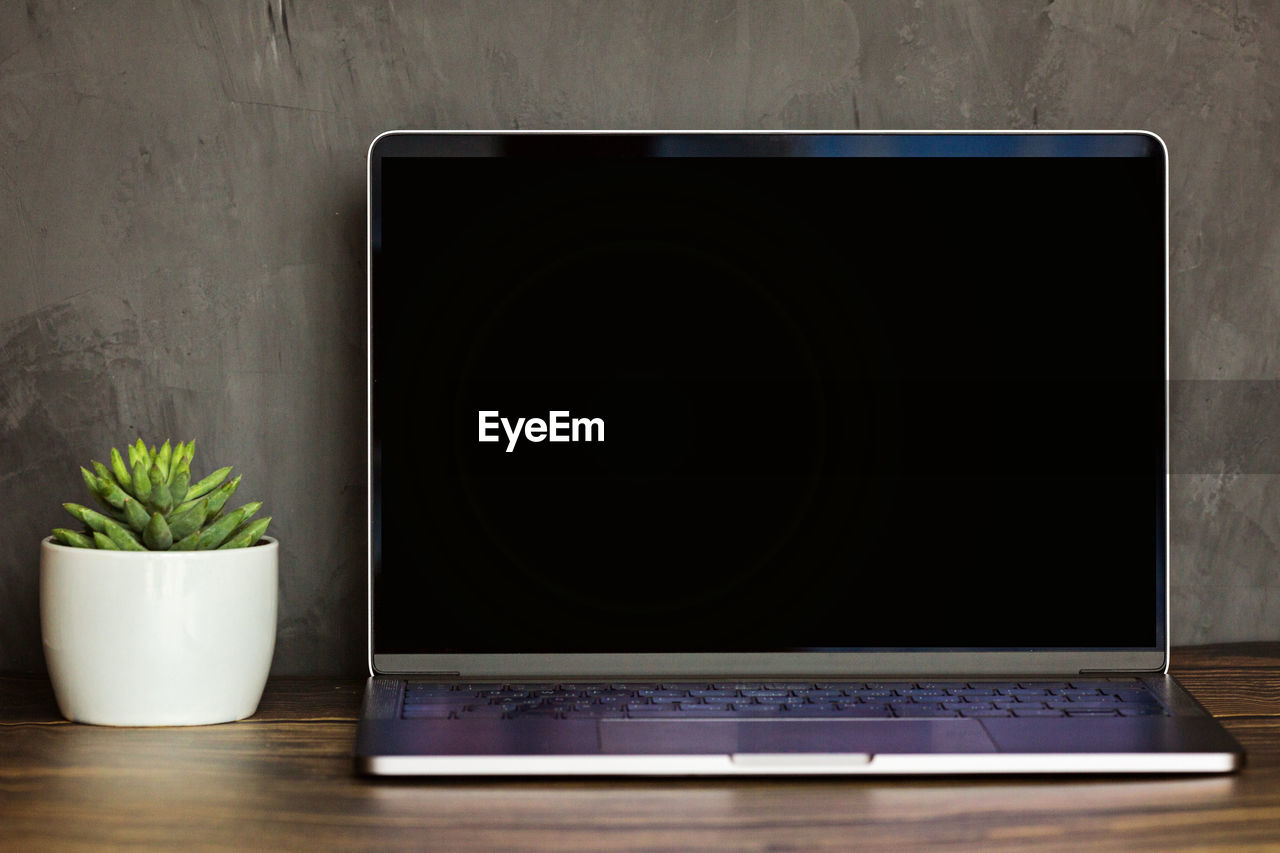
[356,132,1244,776]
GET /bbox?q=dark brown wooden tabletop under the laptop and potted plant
[0,643,1280,852]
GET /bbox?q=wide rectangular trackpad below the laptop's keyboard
[600,720,996,754]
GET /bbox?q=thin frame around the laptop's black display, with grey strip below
[366,131,1170,678]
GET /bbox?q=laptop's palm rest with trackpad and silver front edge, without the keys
[356,676,1244,776]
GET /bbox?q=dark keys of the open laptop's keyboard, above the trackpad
[402,679,1169,720]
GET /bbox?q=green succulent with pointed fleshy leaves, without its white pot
[54,438,271,551]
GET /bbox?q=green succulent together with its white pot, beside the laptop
[40,439,279,726]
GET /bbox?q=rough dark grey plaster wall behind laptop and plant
[0,0,1280,672]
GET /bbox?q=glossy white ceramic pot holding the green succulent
[40,537,279,726]
